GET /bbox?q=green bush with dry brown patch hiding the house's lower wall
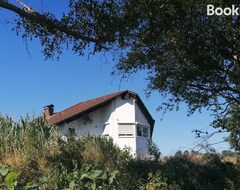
[47,136,131,171]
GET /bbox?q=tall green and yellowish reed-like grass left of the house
[0,115,56,165]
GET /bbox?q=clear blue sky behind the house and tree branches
[0,0,231,155]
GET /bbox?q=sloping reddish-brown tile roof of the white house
[46,90,127,125]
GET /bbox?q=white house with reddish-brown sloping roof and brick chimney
[44,90,154,157]
